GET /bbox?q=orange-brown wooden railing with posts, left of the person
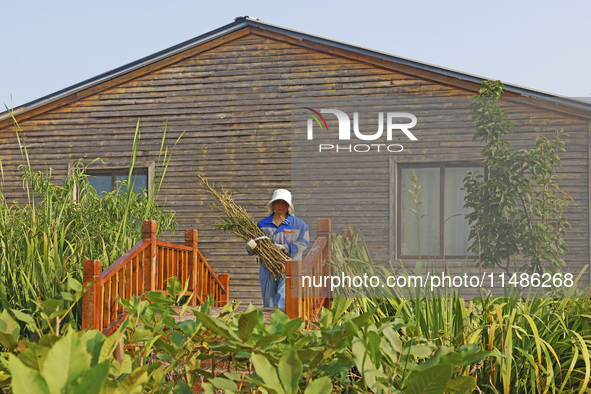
[82,220,230,334]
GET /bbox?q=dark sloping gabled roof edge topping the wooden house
[0,16,591,121]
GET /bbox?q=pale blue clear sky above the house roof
[0,0,591,107]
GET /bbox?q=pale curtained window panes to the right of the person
[397,164,483,258]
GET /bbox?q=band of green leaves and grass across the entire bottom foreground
[0,280,591,393]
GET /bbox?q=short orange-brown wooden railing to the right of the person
[285,219,331,321]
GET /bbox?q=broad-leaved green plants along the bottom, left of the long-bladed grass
[0,279,499,394]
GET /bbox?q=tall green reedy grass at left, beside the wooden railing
[0,114,178,330]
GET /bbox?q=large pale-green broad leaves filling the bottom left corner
[0,310,148,394]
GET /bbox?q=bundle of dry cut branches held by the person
[197,175,287,279]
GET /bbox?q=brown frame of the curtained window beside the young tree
[390,159,487,261]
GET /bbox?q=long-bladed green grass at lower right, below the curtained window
[331,231,591,393]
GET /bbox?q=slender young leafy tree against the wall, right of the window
[464,81,571,272]
